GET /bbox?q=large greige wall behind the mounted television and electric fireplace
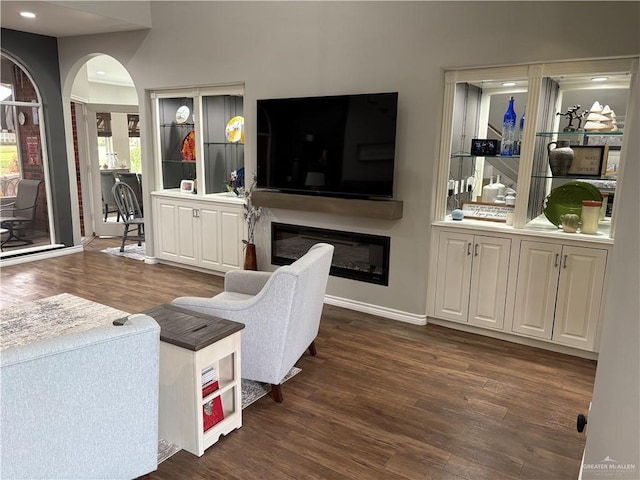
[59,1,640,316]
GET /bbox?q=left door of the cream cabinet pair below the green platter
[513,241,562,340]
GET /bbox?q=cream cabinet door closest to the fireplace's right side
[435,232,473,323]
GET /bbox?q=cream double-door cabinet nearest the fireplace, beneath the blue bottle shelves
[435,231,511,330]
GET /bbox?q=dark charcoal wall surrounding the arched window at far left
[1,28,73,246]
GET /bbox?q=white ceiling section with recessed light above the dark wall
[0,0,149,37]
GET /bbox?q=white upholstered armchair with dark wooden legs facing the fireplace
[172,243,333,402]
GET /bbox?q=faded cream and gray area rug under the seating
[0,293,301,464]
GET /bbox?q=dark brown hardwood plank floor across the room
[1,239,596,480]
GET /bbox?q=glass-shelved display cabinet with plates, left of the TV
[151,85,244,194]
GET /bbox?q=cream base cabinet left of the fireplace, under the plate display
[153,194,244,272]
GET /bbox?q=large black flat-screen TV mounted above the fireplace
[257,92,398,198]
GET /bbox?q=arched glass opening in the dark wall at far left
[0,52,55,257]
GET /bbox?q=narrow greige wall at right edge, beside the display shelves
[582,62,640,480]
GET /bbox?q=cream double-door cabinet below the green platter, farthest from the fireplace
[513,241,607,351]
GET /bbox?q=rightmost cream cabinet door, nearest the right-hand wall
[553,246,607,350]
